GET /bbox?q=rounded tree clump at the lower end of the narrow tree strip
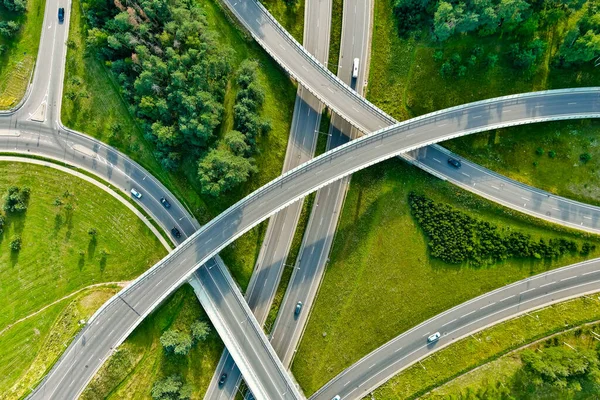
[198,149,257,196]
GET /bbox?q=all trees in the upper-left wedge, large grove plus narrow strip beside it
[80,0,271,196]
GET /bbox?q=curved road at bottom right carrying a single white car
[311,259,600,400]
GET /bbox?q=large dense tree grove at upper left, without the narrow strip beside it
[86,0,231,169]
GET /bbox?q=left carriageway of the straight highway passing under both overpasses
[204,0,331,399]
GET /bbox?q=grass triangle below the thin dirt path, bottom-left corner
[0,285,120,400]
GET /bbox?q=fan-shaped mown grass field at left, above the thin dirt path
[0,162,166,329]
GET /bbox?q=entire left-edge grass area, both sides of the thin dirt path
[0,162,166,397]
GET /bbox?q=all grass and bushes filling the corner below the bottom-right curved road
[373,293,600,400]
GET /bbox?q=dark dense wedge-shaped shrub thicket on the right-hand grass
[408,192,595,266]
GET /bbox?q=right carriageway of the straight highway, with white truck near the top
[271,0,373,367]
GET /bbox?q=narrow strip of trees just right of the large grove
[198,60,271,196]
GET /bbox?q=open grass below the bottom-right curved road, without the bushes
[373,294,600,400]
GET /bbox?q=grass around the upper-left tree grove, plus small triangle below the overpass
[62,0,296,288]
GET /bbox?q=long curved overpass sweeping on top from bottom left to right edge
[32,88,600,399]
